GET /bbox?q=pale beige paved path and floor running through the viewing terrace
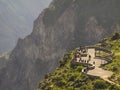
[87,48,115,84]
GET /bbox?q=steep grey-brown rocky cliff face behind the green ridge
[0,0,120,90]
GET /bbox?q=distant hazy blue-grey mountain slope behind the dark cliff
[0,0,51,54]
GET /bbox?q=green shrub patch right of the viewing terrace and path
[100,33,120,84]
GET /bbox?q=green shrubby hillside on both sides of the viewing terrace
[37,36,120,90]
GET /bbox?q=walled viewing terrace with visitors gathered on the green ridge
[73,46,114,73]
